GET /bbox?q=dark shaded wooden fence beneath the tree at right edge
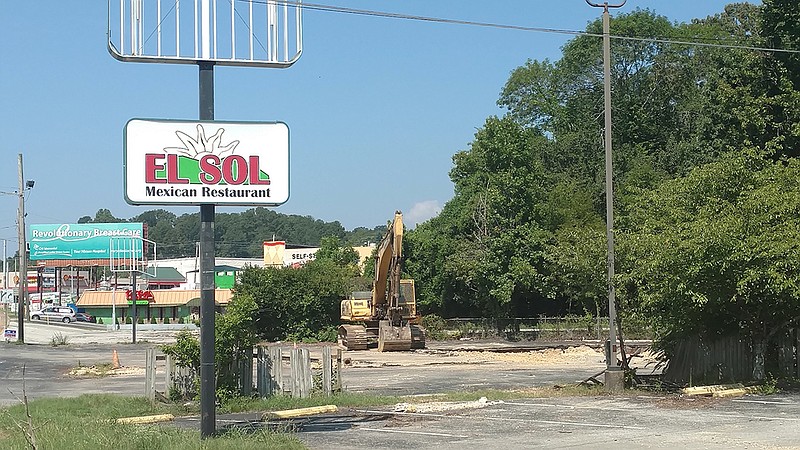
[664,329,800,385]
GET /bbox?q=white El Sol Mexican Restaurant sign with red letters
[124,119,289,206]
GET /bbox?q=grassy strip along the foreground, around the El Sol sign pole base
[0,387,603,450]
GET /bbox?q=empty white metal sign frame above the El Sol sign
[108,0,303,68]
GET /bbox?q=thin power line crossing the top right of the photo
[247,0,800,54]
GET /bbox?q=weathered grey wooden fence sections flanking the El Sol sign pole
[145,346,342,401]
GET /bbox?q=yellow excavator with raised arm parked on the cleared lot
[339,211,425,352]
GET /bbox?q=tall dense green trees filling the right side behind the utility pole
[406,0,800,372]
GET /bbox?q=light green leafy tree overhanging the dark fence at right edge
[621,155,800,378]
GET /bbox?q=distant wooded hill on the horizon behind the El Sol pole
[78,208,386,258]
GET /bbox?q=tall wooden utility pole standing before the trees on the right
[586,0,627,392]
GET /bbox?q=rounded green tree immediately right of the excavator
[407,117,550,317]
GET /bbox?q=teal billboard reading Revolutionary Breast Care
[28,223,144,260]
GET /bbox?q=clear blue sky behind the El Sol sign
[0,0,760,246]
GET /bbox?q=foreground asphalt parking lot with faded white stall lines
[290,395,800,450]
